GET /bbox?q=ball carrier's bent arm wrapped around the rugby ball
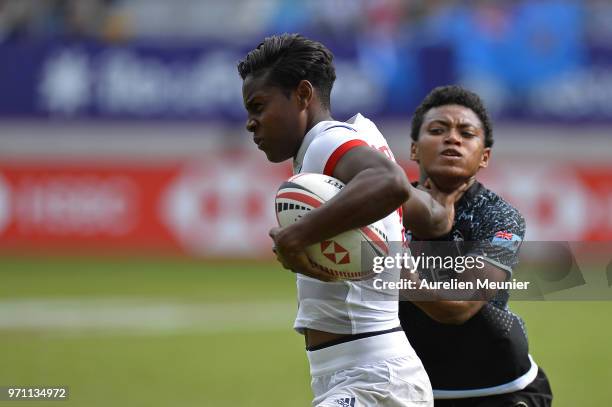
[270,146,411,281]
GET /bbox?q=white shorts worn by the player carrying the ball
[308,331,433,407]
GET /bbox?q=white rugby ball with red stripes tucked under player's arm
[276,173,389,280]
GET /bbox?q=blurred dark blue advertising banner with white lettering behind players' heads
[0,41,612,122]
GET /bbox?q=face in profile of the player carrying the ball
[242,74,306,163]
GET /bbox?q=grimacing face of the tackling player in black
[411,105,491,186]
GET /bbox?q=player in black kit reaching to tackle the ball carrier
[399,86,552,407]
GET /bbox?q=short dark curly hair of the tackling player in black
[410,85,493,147]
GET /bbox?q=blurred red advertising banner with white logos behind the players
[0,152,612,257]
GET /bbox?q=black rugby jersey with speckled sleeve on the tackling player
[399,182,537,398]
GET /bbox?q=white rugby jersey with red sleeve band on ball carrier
[293,114,404,334]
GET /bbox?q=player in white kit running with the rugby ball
[238,34,449,407]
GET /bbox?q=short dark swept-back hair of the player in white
[238,34,336,109]
